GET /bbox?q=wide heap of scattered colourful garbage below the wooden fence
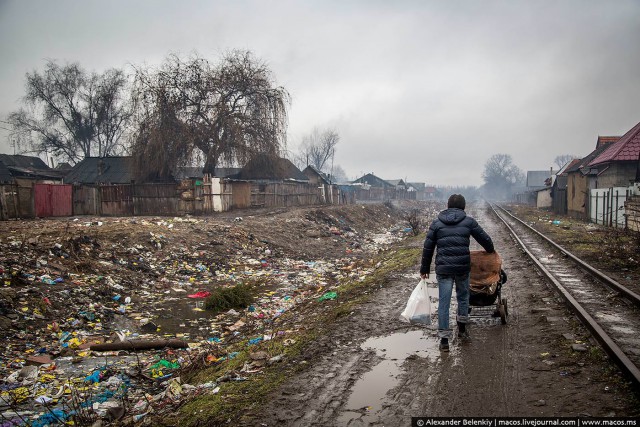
[0,206,416,427]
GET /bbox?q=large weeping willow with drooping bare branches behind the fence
[132,51,290,180]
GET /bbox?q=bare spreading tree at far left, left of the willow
[8,61,130,163]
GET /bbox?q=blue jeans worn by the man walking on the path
[436,273,470,338]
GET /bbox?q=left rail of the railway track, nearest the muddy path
[489,203,640,387]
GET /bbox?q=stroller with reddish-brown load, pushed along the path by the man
[469,251,509,325]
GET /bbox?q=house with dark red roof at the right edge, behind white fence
[589,119,640,188]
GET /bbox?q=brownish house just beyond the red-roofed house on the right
[565,136,620,219]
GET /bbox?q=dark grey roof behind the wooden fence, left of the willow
[64,157,134,184]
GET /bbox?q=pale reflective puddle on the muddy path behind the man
[337,329,440,426]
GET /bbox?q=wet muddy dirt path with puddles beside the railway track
[258,204,638,426]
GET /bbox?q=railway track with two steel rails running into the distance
[490,204,640,387]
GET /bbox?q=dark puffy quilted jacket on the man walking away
[420,208,494,275]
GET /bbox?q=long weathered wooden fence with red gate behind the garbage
[0,177,354,220]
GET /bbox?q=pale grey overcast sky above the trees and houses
[0,0,640,185]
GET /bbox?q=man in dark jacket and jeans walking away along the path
[420,194,494,351]
